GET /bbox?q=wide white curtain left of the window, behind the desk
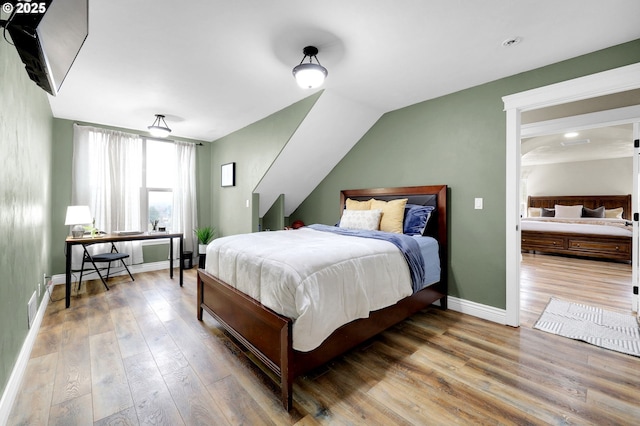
[71,124,143,269]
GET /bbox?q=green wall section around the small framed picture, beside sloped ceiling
[211,92,322,237]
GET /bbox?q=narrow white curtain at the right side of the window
[172,142,198,258]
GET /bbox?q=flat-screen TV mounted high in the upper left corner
[6,0,89,96]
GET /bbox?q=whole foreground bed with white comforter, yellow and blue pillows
[197,185,447,409]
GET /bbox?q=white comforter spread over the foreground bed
[205,228,412,351]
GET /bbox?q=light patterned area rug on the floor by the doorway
[534,297,640,357]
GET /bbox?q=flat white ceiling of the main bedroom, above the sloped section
[49,0,640,141]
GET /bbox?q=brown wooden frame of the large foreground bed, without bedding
[197,185,448,410]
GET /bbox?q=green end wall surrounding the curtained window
[51,118,211,274]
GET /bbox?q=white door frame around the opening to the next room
[502,63,640,327]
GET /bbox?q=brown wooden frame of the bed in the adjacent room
[521,195,632,262]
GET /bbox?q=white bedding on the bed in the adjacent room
[521,217,632,237]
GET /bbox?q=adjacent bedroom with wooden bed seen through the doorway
[520,110,634,324]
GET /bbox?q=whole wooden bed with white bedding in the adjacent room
[521,195,632,262]
